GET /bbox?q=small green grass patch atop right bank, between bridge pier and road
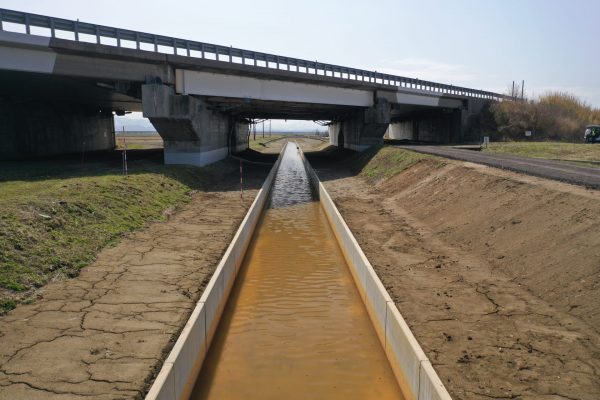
[358,146,444,181]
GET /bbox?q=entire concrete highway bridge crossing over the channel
[0,9,502,166]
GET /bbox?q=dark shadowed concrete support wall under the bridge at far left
[0,99,115,160]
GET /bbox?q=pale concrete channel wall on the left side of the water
[146,150,283,400]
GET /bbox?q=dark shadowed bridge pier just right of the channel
[329,99,391,151]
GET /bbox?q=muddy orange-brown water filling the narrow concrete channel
[191,143,402,400]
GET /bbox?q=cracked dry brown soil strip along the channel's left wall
[0,161,268,400]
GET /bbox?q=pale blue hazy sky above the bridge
[0,0,600,130]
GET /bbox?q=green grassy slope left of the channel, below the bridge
[0,153,211,313]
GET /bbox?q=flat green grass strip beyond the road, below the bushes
[483,142,600,167]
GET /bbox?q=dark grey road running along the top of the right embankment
[398,146,600,189]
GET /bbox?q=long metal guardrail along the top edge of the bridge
[0,8,505,100]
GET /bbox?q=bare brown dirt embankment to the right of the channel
[312,150,600,400]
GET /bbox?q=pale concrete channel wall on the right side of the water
[299,150,451,400]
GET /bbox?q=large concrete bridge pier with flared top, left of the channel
[142,84,248,166]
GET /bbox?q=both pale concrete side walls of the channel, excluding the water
[146,147,450,400]
